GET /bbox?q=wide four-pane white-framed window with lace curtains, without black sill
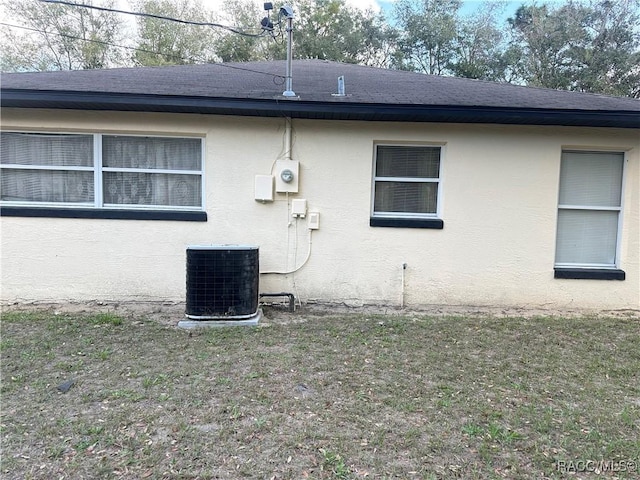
[0,132,203,210]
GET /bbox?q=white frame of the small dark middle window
[370,142,445,219]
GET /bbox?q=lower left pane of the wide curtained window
[1,169,94,203]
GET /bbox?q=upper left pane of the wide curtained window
[0,132,93,167]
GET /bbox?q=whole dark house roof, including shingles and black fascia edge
[2,60,640,128]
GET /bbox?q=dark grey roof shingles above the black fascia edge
[2,60,640,112]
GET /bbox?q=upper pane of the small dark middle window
[376,145,440,178]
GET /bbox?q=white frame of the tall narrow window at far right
[554,148,627,270]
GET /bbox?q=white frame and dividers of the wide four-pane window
[0,130,206,212]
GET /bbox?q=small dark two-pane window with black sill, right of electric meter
[370,145,443,228]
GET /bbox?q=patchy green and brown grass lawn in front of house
[0,311,640,480]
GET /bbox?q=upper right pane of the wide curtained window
[102,135,202,170]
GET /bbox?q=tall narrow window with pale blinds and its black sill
[555,151,624,279]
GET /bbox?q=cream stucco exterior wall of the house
[1,109,640,309]
